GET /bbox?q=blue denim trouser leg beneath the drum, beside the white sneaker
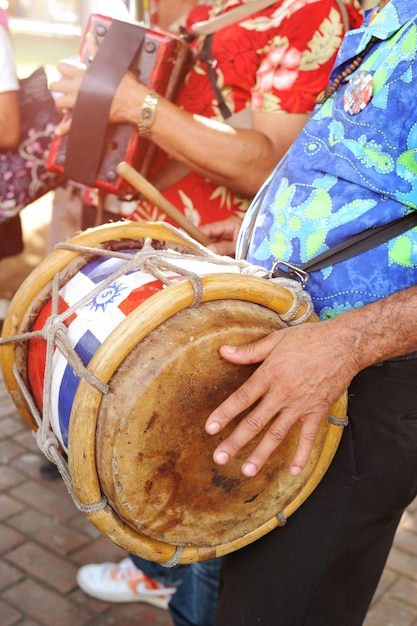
[168,559,222,626]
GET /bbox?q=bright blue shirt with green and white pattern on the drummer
[237,0,417,319]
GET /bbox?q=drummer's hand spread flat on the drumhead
[206,320,357,477]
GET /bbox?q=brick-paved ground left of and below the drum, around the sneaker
[0,370,171,626]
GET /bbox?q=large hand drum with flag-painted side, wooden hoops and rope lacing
[1,222,346,564]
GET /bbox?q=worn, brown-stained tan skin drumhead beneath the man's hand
[96,300,323,546]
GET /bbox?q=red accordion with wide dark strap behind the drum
[47,14,193,198]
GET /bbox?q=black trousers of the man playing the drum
[215,359,417,626]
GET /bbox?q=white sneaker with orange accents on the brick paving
[77,557,177,609]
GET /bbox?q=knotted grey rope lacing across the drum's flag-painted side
[0,224,313,516]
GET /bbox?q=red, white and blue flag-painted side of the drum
[28,251,247,451]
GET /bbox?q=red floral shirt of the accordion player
[131,0,362,226]
